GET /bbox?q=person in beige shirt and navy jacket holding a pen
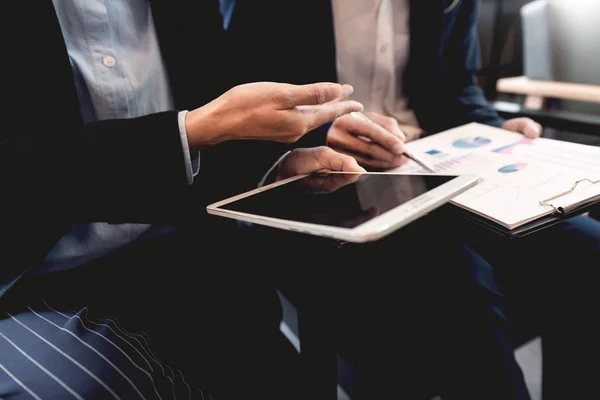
[221,0,600,399]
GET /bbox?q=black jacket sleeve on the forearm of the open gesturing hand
[0,112,197,223]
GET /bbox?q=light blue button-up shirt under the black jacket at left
[37,0,199,274]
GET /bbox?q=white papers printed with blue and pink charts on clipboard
[393,123,600,229]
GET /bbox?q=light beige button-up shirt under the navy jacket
[332,0,422,138]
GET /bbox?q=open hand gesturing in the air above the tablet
[185,82,362,151]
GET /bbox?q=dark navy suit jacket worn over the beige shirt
[224,0,502,143]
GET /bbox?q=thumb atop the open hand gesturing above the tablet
[284,82,354,108]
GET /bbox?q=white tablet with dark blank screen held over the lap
[207,172,478,242]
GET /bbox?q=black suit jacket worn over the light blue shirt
[0,0,280,296]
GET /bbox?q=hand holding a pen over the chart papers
[327,113,406,169]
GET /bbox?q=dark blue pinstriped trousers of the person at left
[0,228,295,400]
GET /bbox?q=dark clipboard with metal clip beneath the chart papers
[449,178,600,239]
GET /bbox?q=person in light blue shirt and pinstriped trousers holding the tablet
[0,0,364,399]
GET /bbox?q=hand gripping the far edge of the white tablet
[276,146,365,180]
